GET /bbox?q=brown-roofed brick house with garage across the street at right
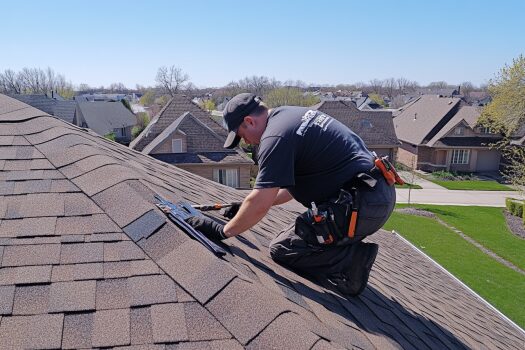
[394,95,501,172]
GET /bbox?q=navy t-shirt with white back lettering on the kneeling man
[255,106,374,206]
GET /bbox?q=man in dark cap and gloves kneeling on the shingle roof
[188,93,395,296]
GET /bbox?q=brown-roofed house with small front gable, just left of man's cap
[130,94,253,188]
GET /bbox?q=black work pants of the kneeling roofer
[270,177,396,278]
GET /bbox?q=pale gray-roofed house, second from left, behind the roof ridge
[74,101,137,145]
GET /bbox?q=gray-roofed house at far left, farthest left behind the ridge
[11,91,77,123]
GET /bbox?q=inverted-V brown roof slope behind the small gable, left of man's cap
[129,94,227,151]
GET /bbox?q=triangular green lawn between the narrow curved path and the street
[400,204,525,270]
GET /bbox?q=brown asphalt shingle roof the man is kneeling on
[0,95,525,349]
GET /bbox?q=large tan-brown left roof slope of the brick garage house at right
[394,95,461,145]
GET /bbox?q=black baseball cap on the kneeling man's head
[223,92,261,148]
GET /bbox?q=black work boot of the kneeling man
[329,242,379,296]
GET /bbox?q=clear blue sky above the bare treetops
[0,0,525,87]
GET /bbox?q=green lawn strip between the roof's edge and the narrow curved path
[385,213,525,327]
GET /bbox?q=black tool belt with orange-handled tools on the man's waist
[295,156,404,245]
